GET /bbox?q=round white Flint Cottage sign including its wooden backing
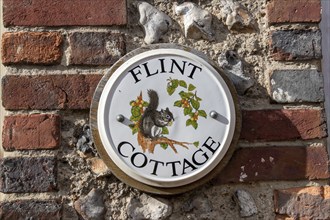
[91,45,240,194]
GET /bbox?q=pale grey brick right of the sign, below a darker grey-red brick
[270,69,324,103]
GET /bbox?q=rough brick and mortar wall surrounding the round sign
[0,0,330,220]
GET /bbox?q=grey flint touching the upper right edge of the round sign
[218,50,254,95]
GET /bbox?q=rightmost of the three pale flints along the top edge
[219,0,257,31]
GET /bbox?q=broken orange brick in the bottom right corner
[274,186,330,219]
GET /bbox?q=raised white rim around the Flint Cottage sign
[97,48,236,188]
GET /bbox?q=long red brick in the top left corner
[3,0,127,27]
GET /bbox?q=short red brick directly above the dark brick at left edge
[2,114,61,151]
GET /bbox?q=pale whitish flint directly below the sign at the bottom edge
[127,194,172,220]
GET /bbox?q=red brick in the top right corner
[267,0,321,24]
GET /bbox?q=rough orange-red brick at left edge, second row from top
[2,32,63,65]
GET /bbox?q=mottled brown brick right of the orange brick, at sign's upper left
[69,32,126,66]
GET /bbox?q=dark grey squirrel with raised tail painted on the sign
[140,90,174,139]
